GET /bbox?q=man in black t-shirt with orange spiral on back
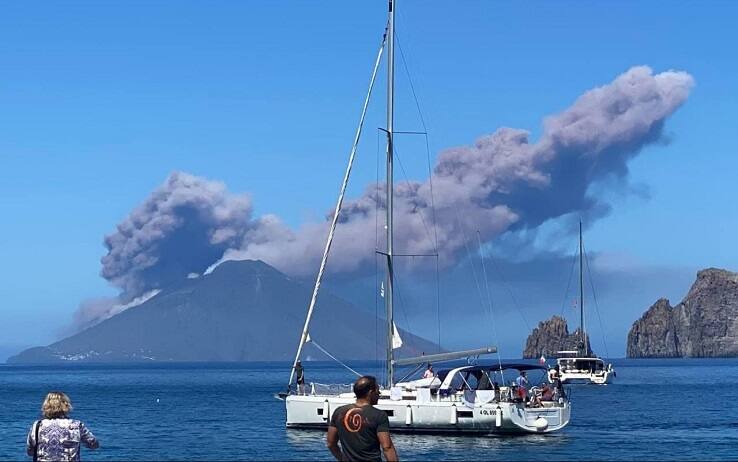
[326,375,399,461]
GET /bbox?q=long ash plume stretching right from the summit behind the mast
[224,66,694,275]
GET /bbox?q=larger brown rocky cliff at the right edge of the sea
[627,268,738,358]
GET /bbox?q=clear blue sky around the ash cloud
[0,0,738,358]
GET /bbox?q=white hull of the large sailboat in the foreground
[286,394,571,434]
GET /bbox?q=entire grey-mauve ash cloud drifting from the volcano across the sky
[85,66,694,328]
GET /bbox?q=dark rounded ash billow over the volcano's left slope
[101,172,252,303]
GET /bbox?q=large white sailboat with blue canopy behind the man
[279,0,571,434]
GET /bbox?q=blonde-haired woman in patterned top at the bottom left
[26,391,100,462]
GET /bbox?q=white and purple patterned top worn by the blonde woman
[26,418,99,462]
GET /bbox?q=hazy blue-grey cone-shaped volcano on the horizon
[8,261,438,363]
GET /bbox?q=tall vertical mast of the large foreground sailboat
[384,0,395,387]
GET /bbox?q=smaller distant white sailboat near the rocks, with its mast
[548,221,615,385]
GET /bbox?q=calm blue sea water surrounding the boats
[0,360,738,460]
